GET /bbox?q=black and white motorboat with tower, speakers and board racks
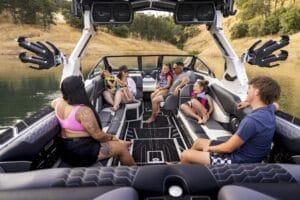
[0,0,300,200]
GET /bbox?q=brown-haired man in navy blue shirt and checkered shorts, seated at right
[180,76,281,165]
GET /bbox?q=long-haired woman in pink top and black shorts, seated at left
[51,76,135,166]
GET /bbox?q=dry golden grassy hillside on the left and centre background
[0,22,184,67]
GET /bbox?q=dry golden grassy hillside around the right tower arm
[184,18,300,77]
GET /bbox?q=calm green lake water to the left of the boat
[0,56,92,127]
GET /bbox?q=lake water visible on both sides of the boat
[0,55,300,126]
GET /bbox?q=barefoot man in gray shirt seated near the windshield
[145,62,190,123]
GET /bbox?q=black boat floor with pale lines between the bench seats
[124,102,190,165]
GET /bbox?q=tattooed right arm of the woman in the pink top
[76,106,117,142]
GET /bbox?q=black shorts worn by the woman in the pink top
[58,137,101,166]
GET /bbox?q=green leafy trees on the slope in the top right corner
[231,0,300,39]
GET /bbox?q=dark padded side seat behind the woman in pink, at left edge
[0,112,60,169]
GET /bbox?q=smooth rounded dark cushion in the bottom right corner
[218,183,300,200]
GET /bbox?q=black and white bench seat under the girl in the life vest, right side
[179,83,255,141]
